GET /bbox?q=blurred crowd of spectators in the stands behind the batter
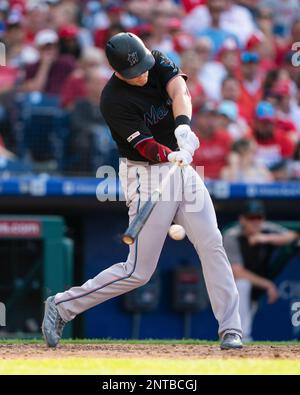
[0,0,300,182]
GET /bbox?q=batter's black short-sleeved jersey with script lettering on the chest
[100,50,186,162]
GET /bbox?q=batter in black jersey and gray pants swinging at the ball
[42,33,242,349]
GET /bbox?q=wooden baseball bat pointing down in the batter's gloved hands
[122,162,179,245]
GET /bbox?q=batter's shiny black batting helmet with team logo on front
[105,33,155,79]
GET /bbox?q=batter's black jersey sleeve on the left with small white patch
[100,103,153,148]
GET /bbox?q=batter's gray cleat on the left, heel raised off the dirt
[42,296,66,347]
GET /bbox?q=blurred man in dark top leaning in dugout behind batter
[224,200,298,341]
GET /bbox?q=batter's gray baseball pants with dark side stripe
[55,161,242,337]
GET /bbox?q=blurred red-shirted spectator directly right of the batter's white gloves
[193,108,232,179]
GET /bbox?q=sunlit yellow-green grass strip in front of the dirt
[0,358,300,375]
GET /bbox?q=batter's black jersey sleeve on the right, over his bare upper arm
[152,50,187,88]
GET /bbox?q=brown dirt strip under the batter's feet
[0,344,300,360]
